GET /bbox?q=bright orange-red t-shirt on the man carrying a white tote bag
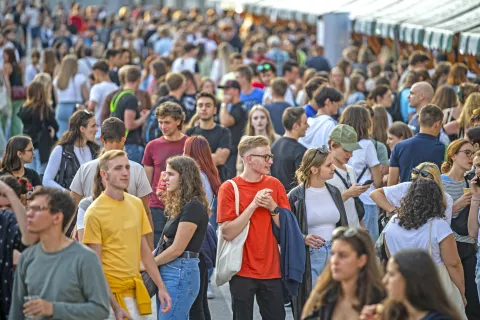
[217,176,290,279]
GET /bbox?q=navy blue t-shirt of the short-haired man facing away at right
[390,133,445,182]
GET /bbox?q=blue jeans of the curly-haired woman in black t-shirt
[156,258,200,320]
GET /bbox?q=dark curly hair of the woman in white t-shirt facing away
[398,179,445,230]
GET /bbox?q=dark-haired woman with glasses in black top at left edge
[0,136,42,195]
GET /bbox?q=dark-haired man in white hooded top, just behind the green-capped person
[298,87,343,148]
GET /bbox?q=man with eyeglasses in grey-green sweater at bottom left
[10,187,109,320]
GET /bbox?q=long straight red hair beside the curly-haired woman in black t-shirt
[183,136,221,196]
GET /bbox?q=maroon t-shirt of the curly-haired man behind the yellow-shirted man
[142,136,188,209]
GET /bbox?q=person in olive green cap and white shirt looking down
[327,124,369,227]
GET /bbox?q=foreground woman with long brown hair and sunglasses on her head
[302,227,385,320]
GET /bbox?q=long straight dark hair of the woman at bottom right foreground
[384,250,460,320]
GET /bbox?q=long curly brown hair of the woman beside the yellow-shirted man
[162,156,208,218]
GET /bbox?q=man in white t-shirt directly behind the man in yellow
[70,117,155,250]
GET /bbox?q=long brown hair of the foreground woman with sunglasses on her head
[302,227,385,319]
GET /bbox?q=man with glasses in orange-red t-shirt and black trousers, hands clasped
[217,136,290,320]
